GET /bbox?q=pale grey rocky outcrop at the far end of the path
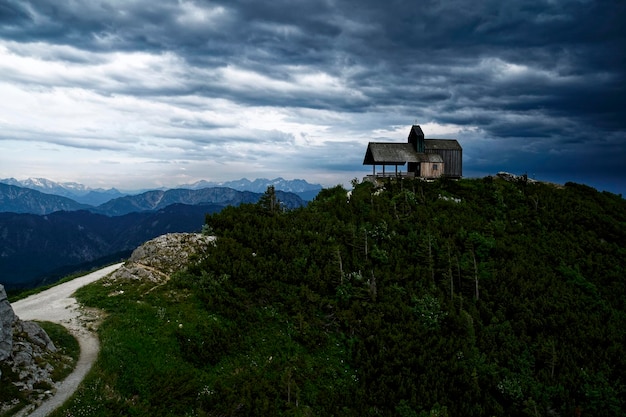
[111,233,214,283]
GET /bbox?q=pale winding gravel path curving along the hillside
[11,263,122,417]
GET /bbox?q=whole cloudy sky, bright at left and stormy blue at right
[0,0,626,194]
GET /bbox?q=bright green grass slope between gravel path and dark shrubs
[53,281,202,416]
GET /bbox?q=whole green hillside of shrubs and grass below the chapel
[51,178,626,416]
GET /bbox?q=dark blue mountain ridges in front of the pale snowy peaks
[0,181,306,289]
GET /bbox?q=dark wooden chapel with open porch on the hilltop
[363,125,463,178]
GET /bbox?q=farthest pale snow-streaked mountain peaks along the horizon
[0,177,322,206]
